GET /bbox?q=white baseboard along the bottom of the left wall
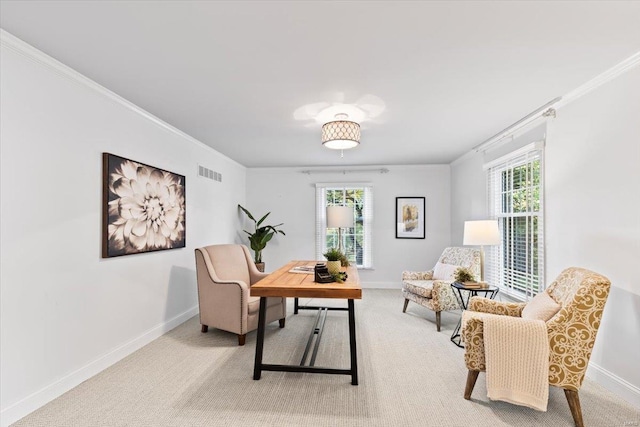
[0,306,198,427]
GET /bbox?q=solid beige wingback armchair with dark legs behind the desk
[195,245,287,345]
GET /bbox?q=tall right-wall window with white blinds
[485,143,545,301]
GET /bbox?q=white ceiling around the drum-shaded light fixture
[0,0,640,167]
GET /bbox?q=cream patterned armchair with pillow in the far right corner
[402,247,480,332]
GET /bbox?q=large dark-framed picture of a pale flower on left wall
[102,153,186,258]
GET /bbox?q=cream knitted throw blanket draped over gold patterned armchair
[482,316,549,412]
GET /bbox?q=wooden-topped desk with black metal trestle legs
[250,261,362,385]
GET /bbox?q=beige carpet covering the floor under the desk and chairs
[14,290,640,427]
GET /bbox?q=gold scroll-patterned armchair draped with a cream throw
[462,267,611,427]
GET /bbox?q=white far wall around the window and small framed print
[245,166,451,288]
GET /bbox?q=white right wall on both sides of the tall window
[451,67,640,407]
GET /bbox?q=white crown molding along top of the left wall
[0,28,246,168]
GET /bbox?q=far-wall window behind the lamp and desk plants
[316,184,373,268]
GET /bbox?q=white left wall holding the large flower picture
[0,32,245,425]
